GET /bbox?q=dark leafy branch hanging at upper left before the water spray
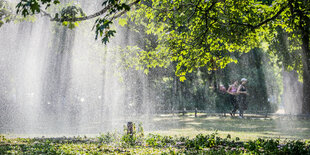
[16,0,140,44]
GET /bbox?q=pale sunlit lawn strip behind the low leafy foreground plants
[0,113,310,141]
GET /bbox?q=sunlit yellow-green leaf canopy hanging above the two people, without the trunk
[122,0,279,81]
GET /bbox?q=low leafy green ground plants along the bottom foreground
[0,133,310,154]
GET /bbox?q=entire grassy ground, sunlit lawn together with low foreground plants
[0,113,310,154]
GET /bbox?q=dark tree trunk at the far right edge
[300,16,310,114]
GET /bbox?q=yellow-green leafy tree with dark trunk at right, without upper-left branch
[124,0,310,114]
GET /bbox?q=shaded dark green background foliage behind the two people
[133,49,281,113]
